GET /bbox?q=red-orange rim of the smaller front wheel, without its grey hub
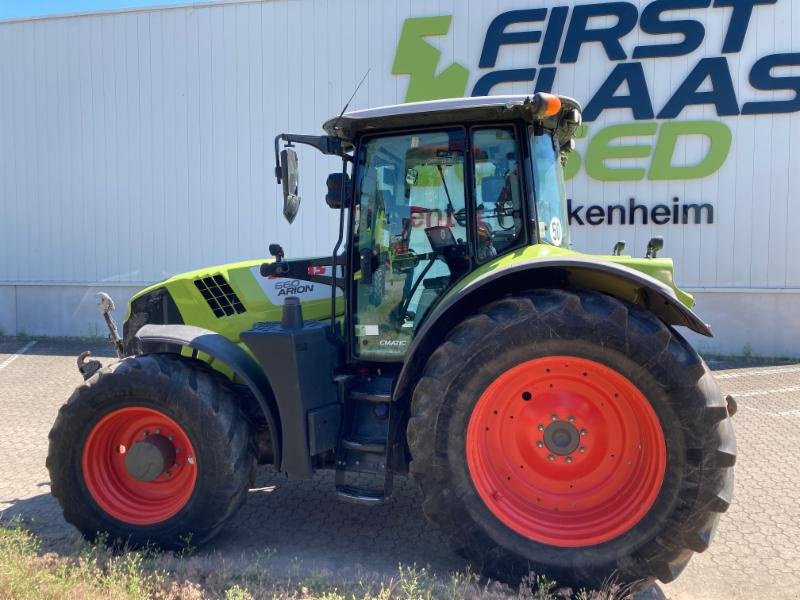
[81,407,197,525]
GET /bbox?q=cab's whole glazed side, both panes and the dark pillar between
[350,125,526,362]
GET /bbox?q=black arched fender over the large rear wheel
[394,257,712,401]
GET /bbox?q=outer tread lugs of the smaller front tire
[46,354,255,548]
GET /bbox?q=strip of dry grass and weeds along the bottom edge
[0,521,629,600]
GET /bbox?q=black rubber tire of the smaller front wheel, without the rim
[47,354,256,549]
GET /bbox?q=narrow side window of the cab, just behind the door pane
[472,127,524,262]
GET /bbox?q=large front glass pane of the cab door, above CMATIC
[351,129,468,361]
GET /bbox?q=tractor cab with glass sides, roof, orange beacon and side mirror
[276,93,581,362]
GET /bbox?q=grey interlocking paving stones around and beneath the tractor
[0,340,800,600]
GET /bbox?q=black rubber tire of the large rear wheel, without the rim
[408,290,736,586]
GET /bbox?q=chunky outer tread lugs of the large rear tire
[407,289,736,581]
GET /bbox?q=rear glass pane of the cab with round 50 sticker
[530,127,570,248]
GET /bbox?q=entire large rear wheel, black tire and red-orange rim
[408,290,735,586]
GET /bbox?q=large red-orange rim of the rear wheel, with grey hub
[467,356,667,548]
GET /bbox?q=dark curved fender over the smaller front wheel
[135,324,281,465]
